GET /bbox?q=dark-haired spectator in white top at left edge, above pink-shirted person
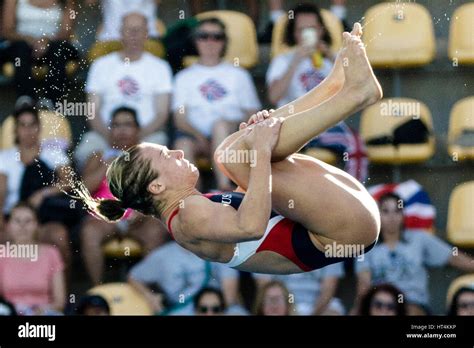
[0,106,71,263]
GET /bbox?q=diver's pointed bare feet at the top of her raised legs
[341,23,383,108]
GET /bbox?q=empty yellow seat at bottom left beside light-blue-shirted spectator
[87,283,153,315]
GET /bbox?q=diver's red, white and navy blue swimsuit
[168,192,375,272]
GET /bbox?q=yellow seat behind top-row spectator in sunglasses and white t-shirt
[183,10,258,69]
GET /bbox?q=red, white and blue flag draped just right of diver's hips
[368,180,436,231]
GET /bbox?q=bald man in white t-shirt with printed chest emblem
[76,13,172,168]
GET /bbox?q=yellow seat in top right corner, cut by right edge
[448,2,474,64]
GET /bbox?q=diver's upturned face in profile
[140,143,199,189]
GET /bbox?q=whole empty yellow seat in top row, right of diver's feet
[362,2,436,68]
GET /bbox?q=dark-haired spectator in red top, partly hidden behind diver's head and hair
[81,107,168,285]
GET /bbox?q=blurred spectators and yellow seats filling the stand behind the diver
[0,0,474,315]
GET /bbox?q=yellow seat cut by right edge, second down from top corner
[448,97,474,161]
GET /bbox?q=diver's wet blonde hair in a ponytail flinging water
[74,145,162,222]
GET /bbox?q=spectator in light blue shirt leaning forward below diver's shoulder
[128,241,243,315]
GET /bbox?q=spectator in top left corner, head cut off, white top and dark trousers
[2,0,78,106]
